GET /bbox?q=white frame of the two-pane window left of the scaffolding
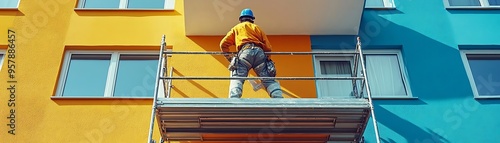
[56,49,166,98]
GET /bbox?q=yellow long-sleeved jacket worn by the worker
[220,22,272,52]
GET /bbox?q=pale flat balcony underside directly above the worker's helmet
[184,0,365,36]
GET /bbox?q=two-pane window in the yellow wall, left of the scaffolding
[58,51,158,97]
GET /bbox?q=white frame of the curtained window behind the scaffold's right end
[313,49,416,99]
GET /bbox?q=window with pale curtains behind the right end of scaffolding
[315,50,411,98]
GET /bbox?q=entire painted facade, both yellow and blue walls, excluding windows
[0,0,500,143]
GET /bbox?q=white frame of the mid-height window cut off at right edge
[460,50,500,99]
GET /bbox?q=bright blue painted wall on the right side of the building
[311,0,500,143]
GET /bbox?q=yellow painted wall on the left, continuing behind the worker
[0,0,316,143]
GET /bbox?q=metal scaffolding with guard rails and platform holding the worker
[148,35,380,143]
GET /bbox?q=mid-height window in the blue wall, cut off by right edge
[462,50,500,98]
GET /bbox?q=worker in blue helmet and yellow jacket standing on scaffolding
[220,8,283,98]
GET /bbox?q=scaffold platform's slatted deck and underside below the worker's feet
[156,98,370,143]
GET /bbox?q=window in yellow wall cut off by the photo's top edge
[78,0,175,10]
